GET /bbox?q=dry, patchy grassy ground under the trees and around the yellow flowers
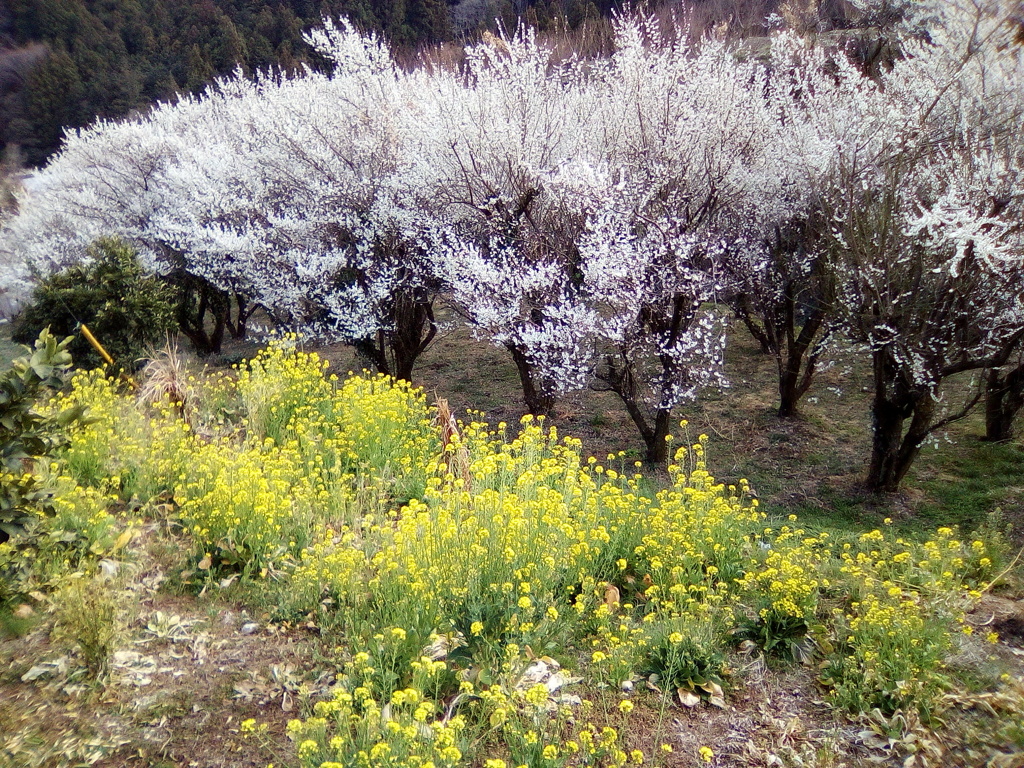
[0,319,1024,768]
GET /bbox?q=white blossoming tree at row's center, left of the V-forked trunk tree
[421,31,599,414]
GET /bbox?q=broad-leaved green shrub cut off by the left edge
[0,329,84,542]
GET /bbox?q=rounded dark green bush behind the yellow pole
[13,238,175,369]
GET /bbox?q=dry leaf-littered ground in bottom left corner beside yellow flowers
[0,523,313,768]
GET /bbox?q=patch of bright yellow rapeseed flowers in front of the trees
[0,339,1019,768]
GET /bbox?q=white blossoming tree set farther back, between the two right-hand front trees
[721,34,890,417]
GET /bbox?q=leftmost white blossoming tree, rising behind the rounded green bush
[0,90,246,351]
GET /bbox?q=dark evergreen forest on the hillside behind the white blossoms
[0,0,634,166]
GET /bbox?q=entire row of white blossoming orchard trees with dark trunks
[0,0,1024,490]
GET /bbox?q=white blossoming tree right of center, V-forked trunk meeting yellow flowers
[582,23,775,463]
